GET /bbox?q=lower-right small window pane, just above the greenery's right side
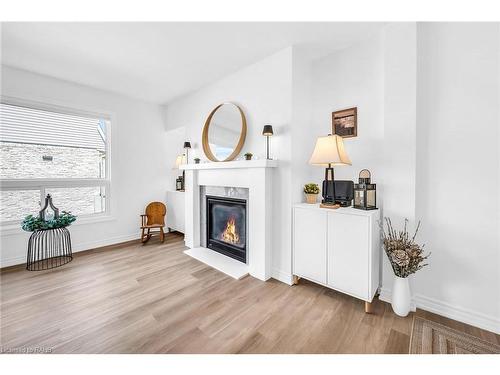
[47,186,106,216]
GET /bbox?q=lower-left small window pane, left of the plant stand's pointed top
[0,190,40,222]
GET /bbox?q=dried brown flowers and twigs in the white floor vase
[382,217,431,277]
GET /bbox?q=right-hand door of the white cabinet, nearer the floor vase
[328,212,370,300]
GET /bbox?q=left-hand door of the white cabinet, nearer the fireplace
[293,208,327,284]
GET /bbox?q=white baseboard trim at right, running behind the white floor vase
[379,288,500,334]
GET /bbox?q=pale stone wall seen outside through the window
[0,142,105,221]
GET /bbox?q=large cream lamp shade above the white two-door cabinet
[309,134,351,166]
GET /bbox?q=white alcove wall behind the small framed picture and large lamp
[305,34,384,188]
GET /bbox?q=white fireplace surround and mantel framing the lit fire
[180,160,278,281]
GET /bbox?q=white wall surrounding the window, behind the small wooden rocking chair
[0,66,172,267]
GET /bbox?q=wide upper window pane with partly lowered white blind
[0,103,109,179]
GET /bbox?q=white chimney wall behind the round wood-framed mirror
[165,48,292,282]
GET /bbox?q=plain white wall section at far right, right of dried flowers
[416,23,500,332]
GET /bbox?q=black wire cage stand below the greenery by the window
[26,228,73,271]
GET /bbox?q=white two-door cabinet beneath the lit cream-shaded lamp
[293,204,380,302]
